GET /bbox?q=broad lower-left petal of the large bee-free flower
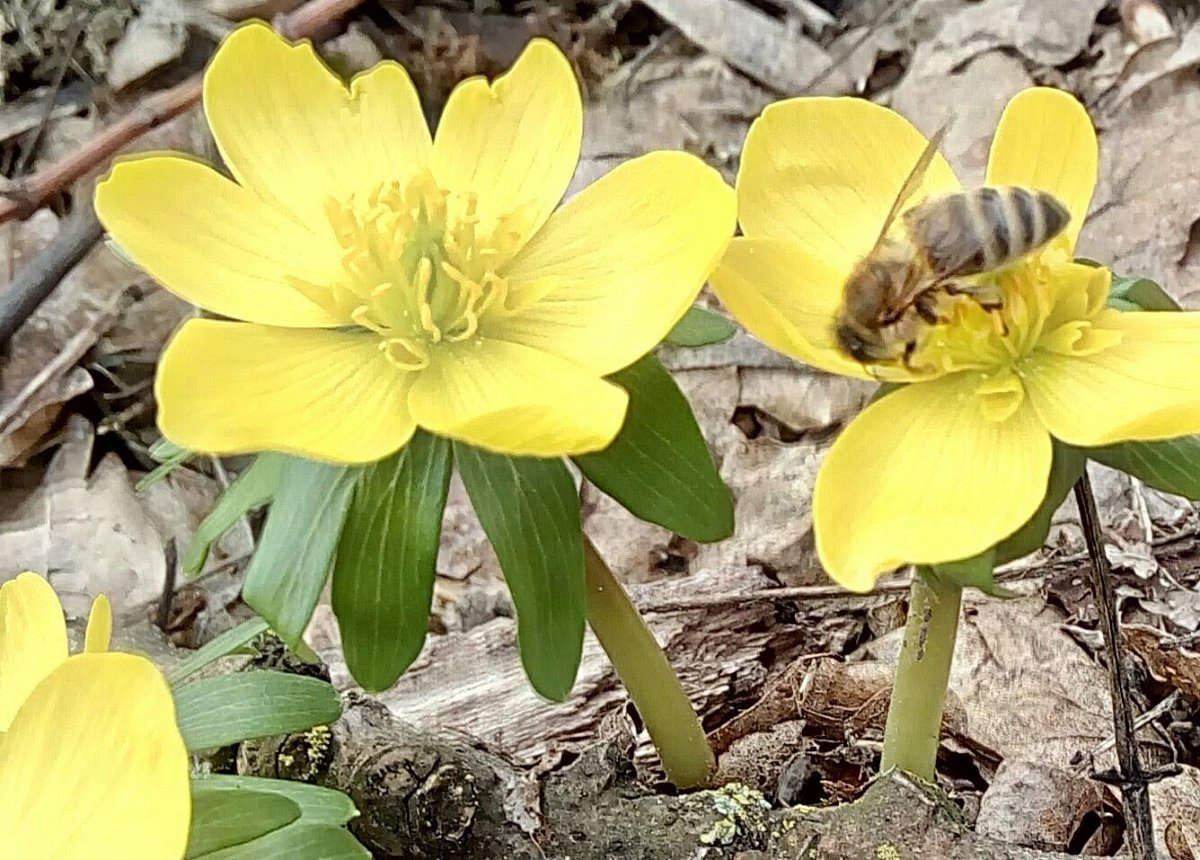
[155,319,414,463]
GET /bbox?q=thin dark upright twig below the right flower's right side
[1075,471,1157,860]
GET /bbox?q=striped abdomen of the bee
[904,187,1070,278]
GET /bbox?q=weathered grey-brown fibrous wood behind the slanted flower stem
[310,563,878,771]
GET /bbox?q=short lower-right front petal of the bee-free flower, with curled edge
[408,339,629,457]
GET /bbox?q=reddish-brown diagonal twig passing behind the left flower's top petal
[0,0,372,223]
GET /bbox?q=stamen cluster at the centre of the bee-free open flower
[293,170,532,371]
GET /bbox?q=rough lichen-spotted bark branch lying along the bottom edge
[239,694,1089,860]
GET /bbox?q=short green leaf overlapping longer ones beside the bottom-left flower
[185,783,300,860]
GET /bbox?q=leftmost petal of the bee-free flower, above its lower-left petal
[96,156,340,326]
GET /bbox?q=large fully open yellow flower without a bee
[96,23,736,463]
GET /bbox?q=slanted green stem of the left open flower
[583,535,716,788]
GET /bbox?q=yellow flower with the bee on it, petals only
[713,89,1200,591]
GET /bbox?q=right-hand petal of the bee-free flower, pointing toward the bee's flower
[494,152,736,375]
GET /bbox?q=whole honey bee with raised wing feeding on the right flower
[834,128,1070,366]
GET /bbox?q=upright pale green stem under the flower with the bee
[880,570,962,782]
